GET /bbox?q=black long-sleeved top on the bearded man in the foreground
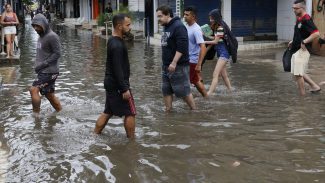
[104,36,130,93]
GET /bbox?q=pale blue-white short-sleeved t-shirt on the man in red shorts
[186,23,204,64]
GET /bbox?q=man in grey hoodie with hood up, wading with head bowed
[29,14,62,114]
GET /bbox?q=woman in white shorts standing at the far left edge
[1,4,19,58]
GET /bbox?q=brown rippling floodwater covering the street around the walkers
[0,20,325,183]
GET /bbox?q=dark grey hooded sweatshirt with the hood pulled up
[32,14,61,74]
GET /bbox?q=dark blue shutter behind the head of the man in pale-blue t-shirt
[184,0,221,25]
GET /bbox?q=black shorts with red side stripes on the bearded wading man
[104,91,136,117]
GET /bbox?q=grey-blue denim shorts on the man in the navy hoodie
[161,65,191,98]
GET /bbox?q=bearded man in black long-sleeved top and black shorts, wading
[94,14,136,139]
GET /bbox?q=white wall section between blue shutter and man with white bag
[277,0,296,40]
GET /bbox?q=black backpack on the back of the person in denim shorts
[222,21,238,63]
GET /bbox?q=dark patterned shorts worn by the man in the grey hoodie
[33,73,59,95]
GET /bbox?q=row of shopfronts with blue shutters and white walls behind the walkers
[51,0,313,40]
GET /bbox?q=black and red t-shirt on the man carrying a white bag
[292,14,318,52]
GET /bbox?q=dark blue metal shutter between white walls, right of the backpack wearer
[231,0,277,36]
